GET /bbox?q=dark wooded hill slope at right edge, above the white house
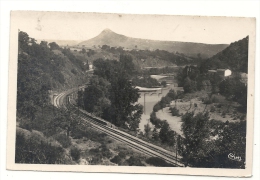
[203,36,249,73]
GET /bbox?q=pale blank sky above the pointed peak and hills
[11,11,251,44]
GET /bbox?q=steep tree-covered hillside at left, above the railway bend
[17,31,88,116]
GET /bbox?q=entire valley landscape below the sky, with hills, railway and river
[16,29,248,168]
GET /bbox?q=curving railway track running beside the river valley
[54,86,184,167]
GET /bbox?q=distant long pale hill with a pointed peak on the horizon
[79,29,228,58]
